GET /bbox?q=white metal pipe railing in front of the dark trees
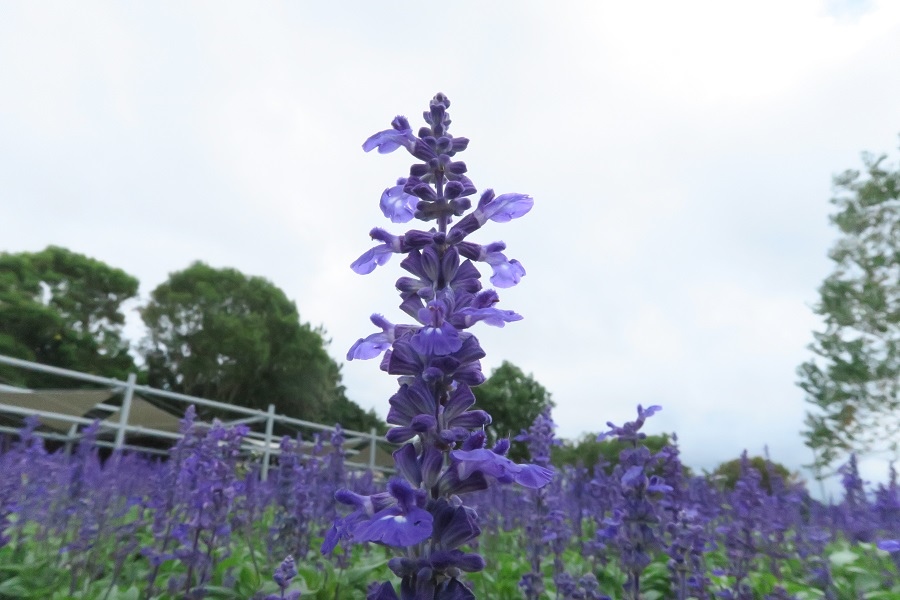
[0,354,393,479]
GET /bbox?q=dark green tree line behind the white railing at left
[0,246,385,431]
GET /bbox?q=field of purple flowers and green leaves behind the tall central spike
[0,407,900,600]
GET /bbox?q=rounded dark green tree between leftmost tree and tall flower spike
[141,262,352,421]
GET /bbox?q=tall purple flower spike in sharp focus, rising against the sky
[322,94,553,600]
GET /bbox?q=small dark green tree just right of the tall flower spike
[472,361,555,458]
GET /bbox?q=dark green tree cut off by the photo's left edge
[0,246,138,388]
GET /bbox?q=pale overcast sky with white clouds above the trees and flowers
[0,0,900,496]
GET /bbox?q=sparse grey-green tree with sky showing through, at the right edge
[797,143,900,477]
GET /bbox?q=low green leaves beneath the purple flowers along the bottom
[0,486,900,600]
